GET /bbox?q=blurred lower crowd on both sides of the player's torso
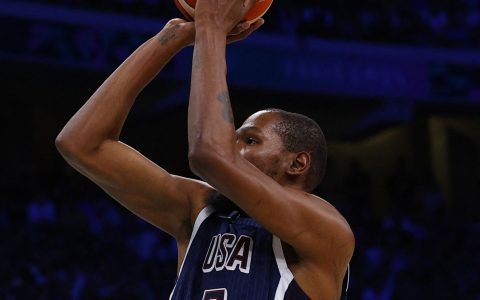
[0,161,480,300]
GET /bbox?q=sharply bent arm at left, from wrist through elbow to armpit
[56,19,209,238]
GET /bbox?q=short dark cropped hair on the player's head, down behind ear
[266,108,327,192]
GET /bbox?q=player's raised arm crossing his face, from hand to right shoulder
[188,0,353,299]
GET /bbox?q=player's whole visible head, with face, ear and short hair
[237,109,327,192]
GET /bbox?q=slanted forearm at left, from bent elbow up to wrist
[57,25,191,152]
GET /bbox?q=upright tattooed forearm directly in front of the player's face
[188,28,235,155]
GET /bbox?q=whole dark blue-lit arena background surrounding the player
[0,0,480,300]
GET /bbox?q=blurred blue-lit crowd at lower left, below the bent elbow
[0,168,177,300]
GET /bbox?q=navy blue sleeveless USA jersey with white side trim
[170,206,348,300]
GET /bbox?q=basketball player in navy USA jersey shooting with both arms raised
[56,0,354,300]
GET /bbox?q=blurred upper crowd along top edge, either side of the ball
[7,0,480,48]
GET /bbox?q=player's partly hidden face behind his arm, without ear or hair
[237,111,288,181]
